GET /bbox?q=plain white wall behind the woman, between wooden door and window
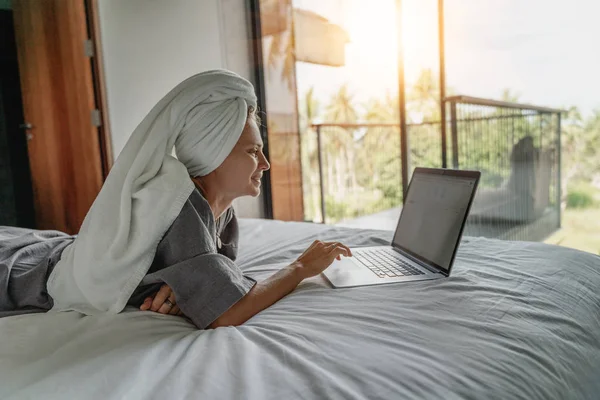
[98,0,264,218]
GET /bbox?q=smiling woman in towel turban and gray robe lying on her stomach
[0,71,351,329]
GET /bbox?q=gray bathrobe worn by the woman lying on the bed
[0,189,256,329]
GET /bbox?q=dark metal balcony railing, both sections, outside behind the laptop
[302,96,561,240]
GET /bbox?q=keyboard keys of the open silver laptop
[352,247,424,278]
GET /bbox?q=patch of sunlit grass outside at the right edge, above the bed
[544,207,600,255]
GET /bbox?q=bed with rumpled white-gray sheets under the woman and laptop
[0,219,600,399]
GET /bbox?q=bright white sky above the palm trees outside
[293,0,600,115]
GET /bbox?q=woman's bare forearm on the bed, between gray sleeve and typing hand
[210,262,304,328]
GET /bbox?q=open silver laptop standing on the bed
[323,168,481,288]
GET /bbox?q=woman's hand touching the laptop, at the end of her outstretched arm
[296,240,352,279]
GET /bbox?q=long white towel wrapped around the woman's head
[48,70,256,314]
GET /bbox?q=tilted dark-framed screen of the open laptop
[393,170,477,271]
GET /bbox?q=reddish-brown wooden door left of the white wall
[13,0,102,233]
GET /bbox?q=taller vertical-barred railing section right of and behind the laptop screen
[446,96,561,240]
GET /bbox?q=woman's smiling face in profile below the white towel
[211,116,270,199]
